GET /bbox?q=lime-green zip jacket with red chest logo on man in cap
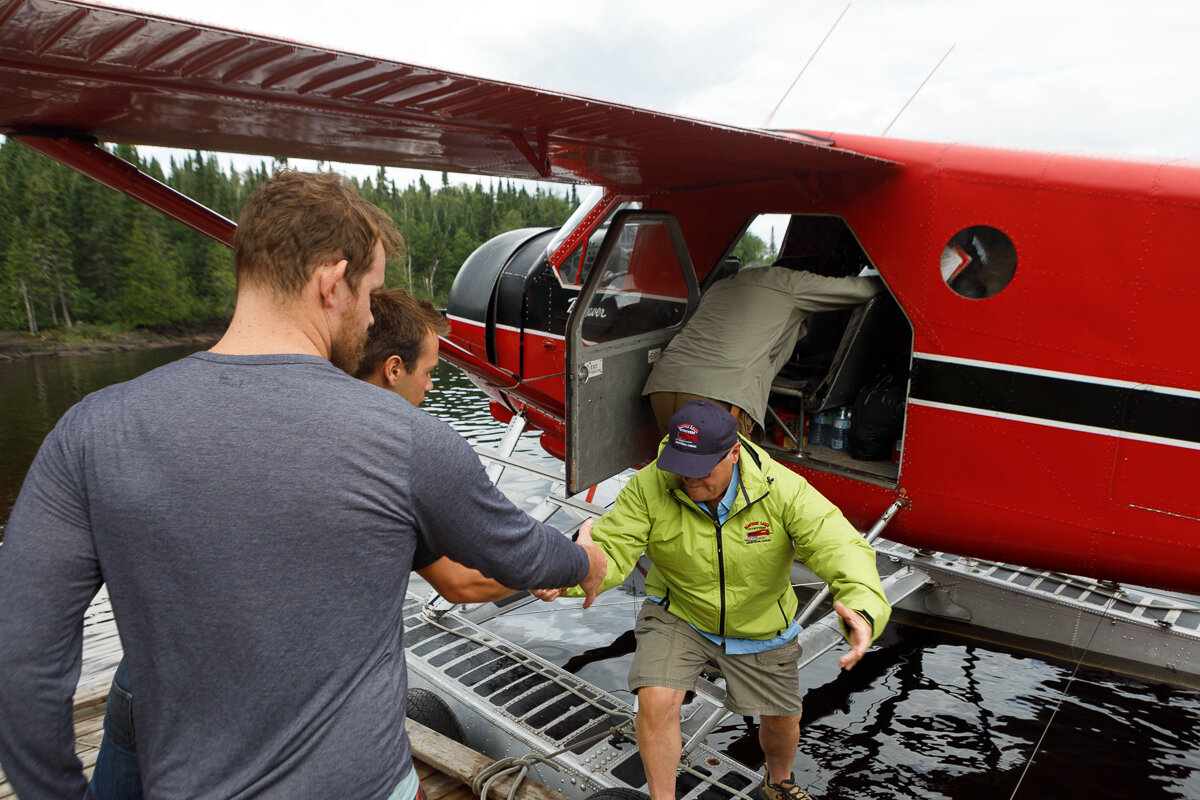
[568,439,892,639]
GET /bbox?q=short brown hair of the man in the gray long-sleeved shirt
[233,169,404,297]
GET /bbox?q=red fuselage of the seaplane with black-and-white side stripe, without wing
[451,136,1200,591]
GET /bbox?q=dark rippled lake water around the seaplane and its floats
[0,349,1200,800]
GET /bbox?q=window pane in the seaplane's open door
[582,222,688,344]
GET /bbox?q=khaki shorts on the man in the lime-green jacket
[629,600,803,717]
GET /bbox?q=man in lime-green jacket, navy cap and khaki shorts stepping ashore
[549,401,890,800]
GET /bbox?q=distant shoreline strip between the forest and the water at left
[0,321,227,362]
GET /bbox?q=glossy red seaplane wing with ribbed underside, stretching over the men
[0,0,887,193]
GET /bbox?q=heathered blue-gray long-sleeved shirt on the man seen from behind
[0,353,587,800]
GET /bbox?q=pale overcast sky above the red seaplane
[109,0,1200,206]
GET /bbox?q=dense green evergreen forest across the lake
[0,139,578,333]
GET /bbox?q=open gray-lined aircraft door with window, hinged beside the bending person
[566,210,700,494]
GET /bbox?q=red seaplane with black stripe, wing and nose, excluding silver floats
[0,0,1200,609]
